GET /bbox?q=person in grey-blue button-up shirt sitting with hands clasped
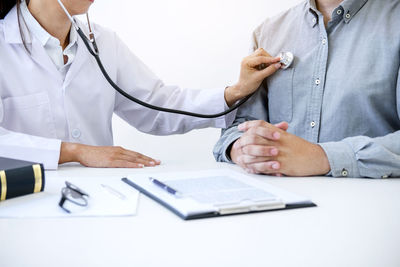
[214,0,400,178]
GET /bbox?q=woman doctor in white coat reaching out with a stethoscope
[0,0,280,169]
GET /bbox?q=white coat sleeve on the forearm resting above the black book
[0,98,61,170]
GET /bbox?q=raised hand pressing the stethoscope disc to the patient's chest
[225,48,281,106]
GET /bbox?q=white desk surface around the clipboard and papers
[0,162,400,267]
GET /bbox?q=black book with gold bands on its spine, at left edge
[0,157,45,201]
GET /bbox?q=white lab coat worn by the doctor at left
[0,8,235,169]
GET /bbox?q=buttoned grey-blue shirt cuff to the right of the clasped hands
[319,142,360,178]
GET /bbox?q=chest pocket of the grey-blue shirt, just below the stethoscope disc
[267,68,294,124]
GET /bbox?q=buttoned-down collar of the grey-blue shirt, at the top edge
[306,0,368,27]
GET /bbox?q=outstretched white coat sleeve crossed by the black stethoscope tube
[115,33,236,135]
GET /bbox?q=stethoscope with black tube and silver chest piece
[58,0,294,119]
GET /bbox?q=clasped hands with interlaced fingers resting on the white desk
[230,121,330,176]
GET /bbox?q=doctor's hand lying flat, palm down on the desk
[59,143,161,168]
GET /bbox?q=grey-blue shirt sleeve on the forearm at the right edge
[320,63,400,178]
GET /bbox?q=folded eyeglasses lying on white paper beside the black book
[58,181,89,213]
